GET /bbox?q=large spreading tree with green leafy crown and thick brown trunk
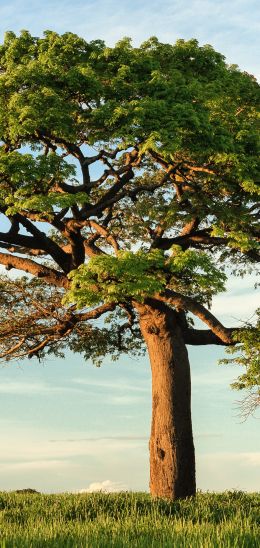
[0,31,259,499]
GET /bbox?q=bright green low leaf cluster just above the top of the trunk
[64,246,226,308]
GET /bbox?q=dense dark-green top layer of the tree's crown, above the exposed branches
[0,31,257,163]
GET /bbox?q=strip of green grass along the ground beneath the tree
[0,491,260,548]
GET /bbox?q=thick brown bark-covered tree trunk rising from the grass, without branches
[137,304,196,500]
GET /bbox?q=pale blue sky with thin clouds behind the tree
[0,0,260,492]
